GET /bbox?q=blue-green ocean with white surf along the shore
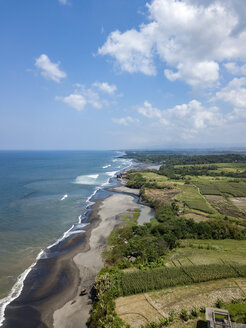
[0,151,131,323]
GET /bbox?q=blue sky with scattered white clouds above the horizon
[0,0,246,150]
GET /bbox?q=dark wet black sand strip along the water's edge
[2,200,101,328]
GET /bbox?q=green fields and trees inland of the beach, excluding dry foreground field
[90,153,246,328]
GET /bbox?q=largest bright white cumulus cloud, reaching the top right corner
[98,0,246,86]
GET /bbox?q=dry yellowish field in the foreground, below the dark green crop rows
[116,278,246,328]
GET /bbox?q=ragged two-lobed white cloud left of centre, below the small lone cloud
[55,82,117,111]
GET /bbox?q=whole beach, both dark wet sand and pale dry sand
[3,182,151,328]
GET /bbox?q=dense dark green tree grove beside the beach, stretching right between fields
[104,203,246,268]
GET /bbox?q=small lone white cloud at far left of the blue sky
[35,54,67,82]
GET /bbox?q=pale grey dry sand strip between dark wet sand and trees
[53,194,141,328]
